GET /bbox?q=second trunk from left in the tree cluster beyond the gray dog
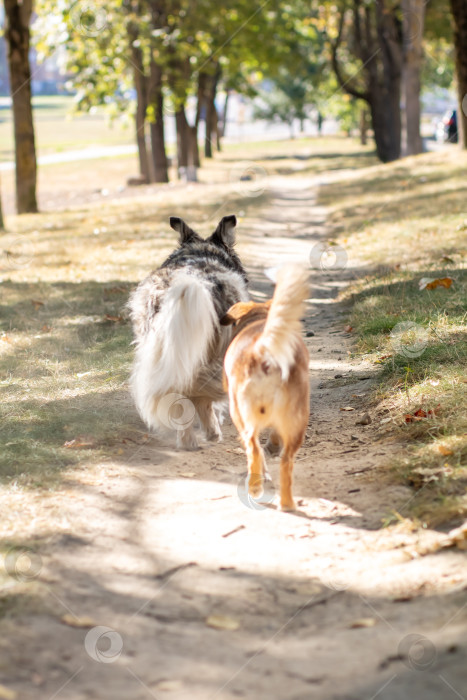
[148,59,169,182]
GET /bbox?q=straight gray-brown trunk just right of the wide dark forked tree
[402,0,426,155]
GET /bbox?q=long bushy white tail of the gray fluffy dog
[131,273,218,428]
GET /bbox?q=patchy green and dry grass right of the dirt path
[321,150,467,525]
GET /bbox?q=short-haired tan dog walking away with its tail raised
[221,265,309,510]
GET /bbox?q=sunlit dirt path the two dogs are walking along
[0,179,467,700]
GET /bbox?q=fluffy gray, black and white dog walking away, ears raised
[128,216,249,449]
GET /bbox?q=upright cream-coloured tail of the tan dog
[257,264,309,381]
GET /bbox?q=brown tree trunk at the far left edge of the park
[5,0,37,214]
